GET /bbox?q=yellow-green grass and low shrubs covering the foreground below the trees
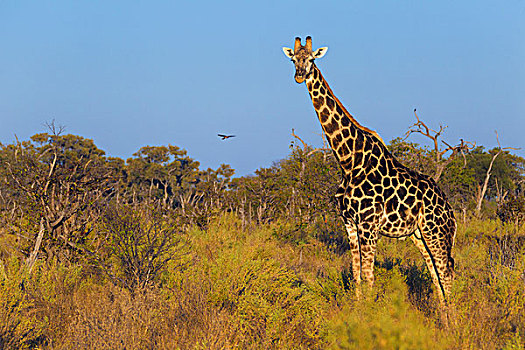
[0,215,525,349]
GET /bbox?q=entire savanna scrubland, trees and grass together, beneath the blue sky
[0,124,525,349]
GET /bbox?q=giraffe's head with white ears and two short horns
[283,36,328,84]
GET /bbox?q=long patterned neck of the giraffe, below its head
[306,64,384,172]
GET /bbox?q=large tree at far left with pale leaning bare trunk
[1,127,117,270]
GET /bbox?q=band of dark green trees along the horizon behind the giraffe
[0,114,525,285]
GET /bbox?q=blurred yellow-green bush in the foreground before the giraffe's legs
[331,268,450,350]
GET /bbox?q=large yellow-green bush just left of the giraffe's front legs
[164,217,342,348]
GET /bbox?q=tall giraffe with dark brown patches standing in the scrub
[283,37,457,304]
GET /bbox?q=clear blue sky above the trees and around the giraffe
[0,0,525,175]
